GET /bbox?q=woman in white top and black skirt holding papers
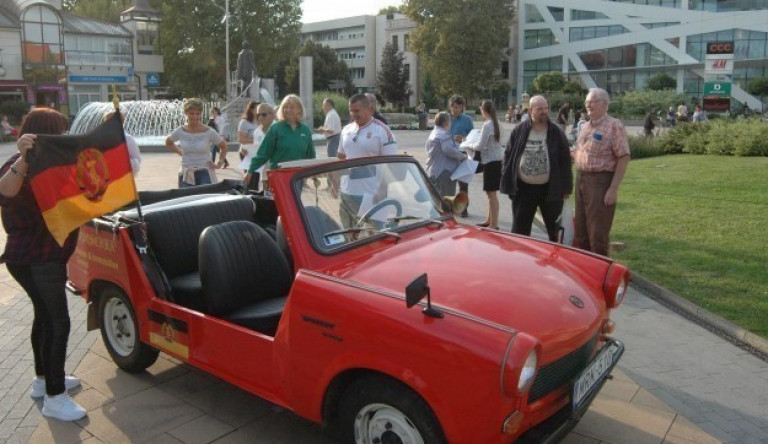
[466,100,504,229]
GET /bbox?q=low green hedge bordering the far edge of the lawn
[629,119,768,159]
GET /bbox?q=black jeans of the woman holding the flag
[7,262,70,396]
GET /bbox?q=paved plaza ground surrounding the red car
[0,126,768,444]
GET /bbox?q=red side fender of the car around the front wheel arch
[280,271,517,442]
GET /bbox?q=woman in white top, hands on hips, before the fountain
[165,99,227,188]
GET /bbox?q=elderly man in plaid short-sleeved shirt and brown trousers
[573,88,629,256]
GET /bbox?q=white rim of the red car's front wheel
[355,404,424,444]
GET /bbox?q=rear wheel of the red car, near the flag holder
[99,287,160,373]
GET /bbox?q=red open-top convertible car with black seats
[68,156,629,444]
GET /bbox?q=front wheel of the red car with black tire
[334,376,448,444]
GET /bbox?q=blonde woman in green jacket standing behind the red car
[245,94,315,183]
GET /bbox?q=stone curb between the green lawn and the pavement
[630,272,768,355]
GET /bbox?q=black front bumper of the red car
[515,338,624,444]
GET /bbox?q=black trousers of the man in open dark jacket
[512,181,563,242]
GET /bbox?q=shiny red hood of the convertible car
[332,226,610,360]
